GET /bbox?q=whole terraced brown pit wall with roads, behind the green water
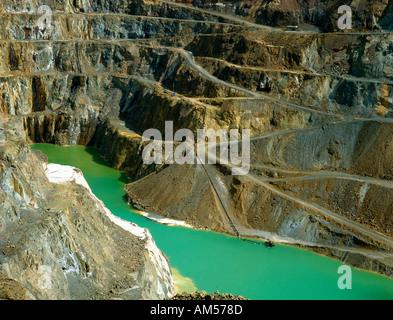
[0,1,393,282]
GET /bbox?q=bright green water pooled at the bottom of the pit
[32,144,393,300]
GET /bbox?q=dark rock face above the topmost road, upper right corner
[176,0,392,32]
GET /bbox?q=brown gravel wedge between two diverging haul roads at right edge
[271,178,393,236]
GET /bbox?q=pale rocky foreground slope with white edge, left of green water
[0,125,174,300]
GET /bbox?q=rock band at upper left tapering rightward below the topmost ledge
[0,11,239,41]
